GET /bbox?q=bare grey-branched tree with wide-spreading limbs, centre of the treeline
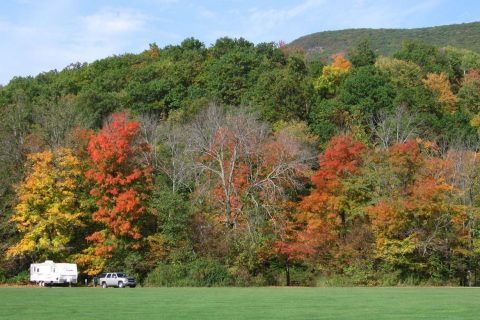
[187,106,309,228]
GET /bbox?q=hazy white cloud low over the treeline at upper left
[0,8,151,84]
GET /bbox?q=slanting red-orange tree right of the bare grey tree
[277,135,365,270]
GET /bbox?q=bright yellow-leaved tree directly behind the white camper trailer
[7,148,84,261]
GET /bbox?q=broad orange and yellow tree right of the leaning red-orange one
[365,140,465,279]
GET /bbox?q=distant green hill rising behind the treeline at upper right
[290,22,480,56]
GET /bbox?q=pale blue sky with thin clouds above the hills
[0,0,480,85]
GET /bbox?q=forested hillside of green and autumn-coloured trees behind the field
[0,38,480,286]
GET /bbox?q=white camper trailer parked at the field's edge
[30,260,78,286]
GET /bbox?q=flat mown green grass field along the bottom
[0,288,480,320]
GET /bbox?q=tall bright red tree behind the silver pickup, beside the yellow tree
[77,113,152,273]
